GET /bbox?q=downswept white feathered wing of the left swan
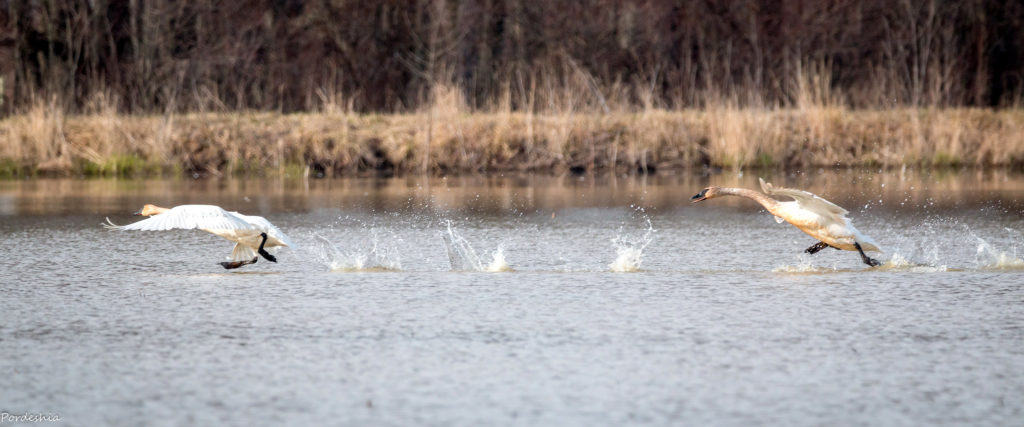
[103,205,259,231]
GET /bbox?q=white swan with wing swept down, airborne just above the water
[103,205,294,269]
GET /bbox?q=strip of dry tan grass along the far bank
[0,94,1024,176]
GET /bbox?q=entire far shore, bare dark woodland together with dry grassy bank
[0,0,1024,173]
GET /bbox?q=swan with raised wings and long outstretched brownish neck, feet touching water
[690,178,882,267]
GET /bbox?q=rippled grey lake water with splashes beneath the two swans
[0,171,1024,426]
